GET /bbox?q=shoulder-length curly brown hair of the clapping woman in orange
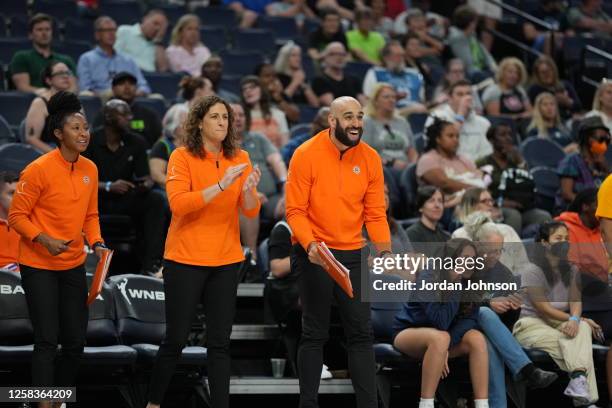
[184,95,238,159]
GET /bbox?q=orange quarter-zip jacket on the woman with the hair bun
[9,149,102,270]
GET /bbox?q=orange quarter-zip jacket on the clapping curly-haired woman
[164,147,261,266]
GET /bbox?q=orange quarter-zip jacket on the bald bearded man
[285,129,391,251]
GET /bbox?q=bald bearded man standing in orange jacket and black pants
[286,96,391,408]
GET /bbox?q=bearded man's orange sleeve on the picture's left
[285,149,316,250]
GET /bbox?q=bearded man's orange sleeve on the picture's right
[363,155,391,252]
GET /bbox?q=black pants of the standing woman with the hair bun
[20,265,88,387]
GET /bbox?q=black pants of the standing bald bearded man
[291,245,377,408]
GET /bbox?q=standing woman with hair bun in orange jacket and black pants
[9,91,105,407]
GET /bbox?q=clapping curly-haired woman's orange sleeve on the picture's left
[166,150,206,216]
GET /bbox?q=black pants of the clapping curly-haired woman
[149,261,240,408]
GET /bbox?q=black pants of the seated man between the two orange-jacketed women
[98,190,167,271]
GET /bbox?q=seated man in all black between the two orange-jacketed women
[85,99,166,275]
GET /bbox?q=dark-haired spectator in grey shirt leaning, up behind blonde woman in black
[448,6,497,82]
